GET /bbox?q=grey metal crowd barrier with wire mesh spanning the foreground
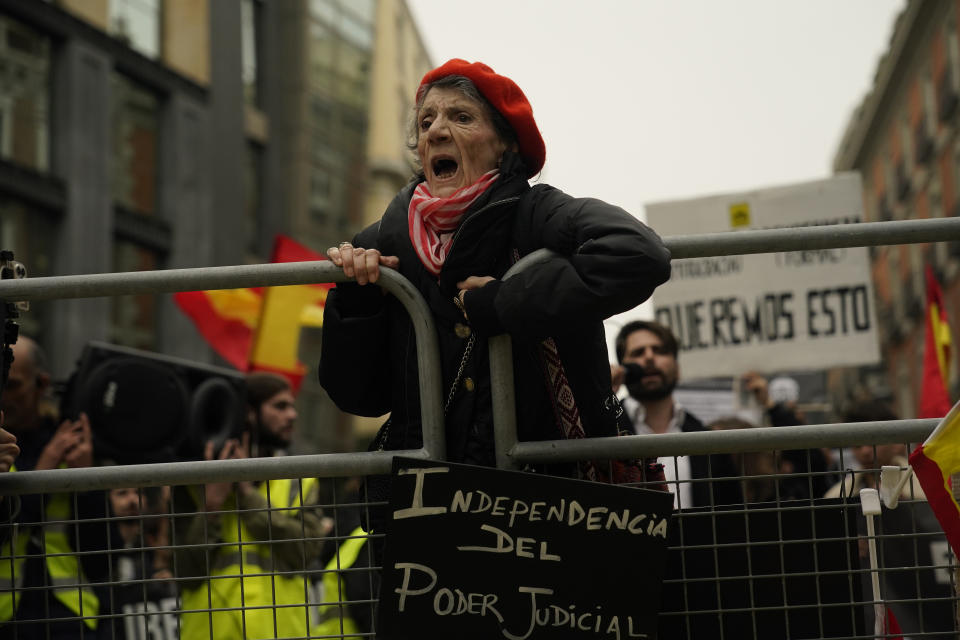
[0,218,960,639]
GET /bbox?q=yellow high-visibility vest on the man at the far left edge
[0,466,100,629]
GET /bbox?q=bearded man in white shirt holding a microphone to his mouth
[611,320,743,508]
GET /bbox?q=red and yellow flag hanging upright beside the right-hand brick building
[918,265,953,418]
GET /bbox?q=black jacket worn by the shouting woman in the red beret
[320,153,670,466]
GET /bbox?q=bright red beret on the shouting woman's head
[417,58,547,178]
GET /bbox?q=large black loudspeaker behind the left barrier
[61,342,245,464]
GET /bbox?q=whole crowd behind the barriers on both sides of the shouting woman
[0,321,923,640]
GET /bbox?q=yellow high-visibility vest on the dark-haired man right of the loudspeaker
[180,478,317,640]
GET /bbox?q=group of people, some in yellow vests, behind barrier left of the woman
[0,337,373,640]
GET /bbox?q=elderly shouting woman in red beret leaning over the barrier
[320,59,670,476]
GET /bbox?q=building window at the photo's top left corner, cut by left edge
[0,16,50,172]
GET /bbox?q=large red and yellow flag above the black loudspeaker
[173,235,333,391]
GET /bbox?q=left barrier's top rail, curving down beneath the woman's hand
[0,261,447,459]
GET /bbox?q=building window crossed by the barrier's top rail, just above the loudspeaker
[110,238,160,351]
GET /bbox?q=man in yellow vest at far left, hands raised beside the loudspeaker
[0,336,108,639]
